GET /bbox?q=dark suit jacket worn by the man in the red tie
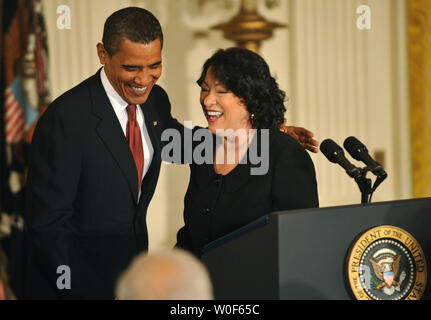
[26,70,183,299]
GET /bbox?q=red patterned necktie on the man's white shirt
[126,104,144,193]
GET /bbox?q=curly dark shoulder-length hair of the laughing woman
[197,48,286,129]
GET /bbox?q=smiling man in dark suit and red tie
[26,7,320,299]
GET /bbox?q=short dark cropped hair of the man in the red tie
[102,7,163,56]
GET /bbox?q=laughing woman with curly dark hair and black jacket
[177,48,318,256]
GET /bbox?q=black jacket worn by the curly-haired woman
[177,128,319,257]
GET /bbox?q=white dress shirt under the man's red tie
[100,68,154,199]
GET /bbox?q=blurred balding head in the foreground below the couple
[116,249,213,300]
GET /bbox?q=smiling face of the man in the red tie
[97,39,162,104]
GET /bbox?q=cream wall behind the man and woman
[43,0,410,250]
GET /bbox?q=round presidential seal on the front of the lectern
[347,226,427,300]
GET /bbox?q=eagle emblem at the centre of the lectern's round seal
[369,248,406,296]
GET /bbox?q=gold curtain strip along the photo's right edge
[408,0,431,198]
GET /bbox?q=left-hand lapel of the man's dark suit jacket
[90,70,138,203]
